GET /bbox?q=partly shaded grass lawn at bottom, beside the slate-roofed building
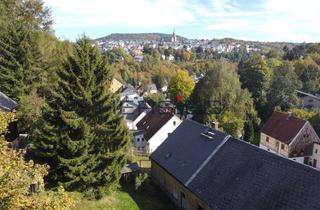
[74,182,175,210]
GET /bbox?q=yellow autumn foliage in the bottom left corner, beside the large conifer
[0,112,74,209]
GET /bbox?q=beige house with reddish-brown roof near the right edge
[259,112,320,167]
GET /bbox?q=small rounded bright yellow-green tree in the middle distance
[168,70,195,102]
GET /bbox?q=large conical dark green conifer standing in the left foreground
[28,37,130,195]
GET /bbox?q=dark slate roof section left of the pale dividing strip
[150,120,227,183]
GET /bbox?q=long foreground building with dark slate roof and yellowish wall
[150,120,320,210]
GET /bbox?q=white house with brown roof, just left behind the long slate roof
[134,109,182,154]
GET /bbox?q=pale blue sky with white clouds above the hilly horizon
[43,0,320,42]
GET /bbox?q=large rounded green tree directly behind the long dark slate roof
[191,61,259,137]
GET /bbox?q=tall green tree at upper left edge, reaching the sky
[0,0,52,100]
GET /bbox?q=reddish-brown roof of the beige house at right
[261,112,306,144]
